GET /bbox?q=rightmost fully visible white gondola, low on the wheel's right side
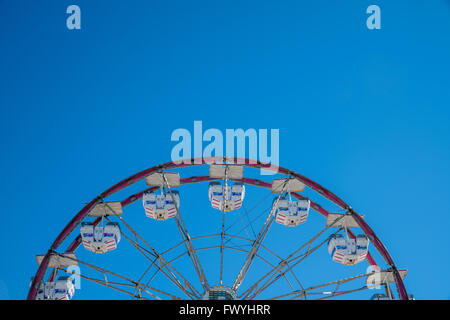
[328,234,369,265]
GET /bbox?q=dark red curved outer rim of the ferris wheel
[27,157,408,300]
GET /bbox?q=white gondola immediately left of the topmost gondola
[142,191,180,220]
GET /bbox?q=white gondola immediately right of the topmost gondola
[274,199,310,227]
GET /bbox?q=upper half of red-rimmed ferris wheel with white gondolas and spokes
[27,157,411,300]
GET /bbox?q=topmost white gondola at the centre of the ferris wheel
[208,182,245,212]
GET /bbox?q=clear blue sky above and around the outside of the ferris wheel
[0,0,450,299]
